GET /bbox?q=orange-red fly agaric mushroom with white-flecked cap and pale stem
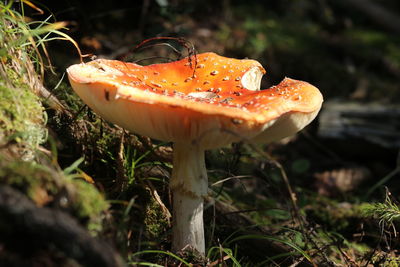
[67,53,322,254]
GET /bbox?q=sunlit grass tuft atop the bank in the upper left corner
[0,0,82,80]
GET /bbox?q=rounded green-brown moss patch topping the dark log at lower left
[0,157,108,233]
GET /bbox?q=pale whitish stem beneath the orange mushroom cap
[170,143,208,254]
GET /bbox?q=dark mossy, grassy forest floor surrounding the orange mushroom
[0,1,400,266]
